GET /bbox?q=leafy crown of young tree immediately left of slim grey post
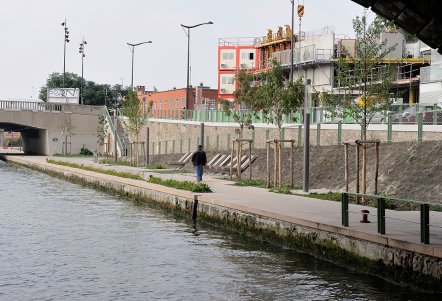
[256,60,304,137]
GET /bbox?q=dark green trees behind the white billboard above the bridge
[39,72,127,107]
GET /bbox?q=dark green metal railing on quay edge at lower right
[341,192,442,244]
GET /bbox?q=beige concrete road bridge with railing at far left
[0,100,104,155]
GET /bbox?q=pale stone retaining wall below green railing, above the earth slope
[140,119,442,154]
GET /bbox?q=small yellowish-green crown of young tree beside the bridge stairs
[121,89,149,142]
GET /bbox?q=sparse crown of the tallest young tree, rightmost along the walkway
[321,10,396,140]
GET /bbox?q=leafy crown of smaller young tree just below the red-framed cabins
[220,70,260,139]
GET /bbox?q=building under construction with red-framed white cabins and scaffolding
[218,20,431,106]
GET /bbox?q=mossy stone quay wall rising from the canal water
[4,158,442,291]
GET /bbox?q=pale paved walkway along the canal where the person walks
[6,156,442,258]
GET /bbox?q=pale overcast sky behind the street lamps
[0,0,363,100]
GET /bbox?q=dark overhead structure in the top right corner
[352,0,442,54]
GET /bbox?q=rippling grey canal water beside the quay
[0,161,440,300]
